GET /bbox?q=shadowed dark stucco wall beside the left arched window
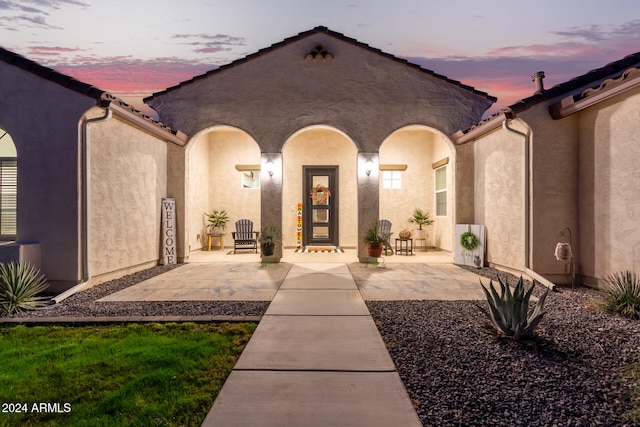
[0,62,95,284]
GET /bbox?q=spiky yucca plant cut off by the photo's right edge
[604,271,640,319]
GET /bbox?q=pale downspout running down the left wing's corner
[49,106,112,304]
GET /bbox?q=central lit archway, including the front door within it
[282,125,358,248]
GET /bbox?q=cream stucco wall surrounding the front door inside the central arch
[282,128,358,247]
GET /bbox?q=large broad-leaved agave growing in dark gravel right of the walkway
[480,276,549,340]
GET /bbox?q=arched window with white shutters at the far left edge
[0,128,18,240]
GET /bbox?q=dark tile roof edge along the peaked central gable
[144,26,497,102]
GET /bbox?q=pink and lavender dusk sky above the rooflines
[0,0,640,115]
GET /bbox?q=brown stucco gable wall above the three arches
[148,33,491,153]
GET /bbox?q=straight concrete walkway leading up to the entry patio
[202,263,422,427]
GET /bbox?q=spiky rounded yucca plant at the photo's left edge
[0,261,48,315]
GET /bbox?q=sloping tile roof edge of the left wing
[0,47,186,145]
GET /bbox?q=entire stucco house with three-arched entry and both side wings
[0,27,640,290]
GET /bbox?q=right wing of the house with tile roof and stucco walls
[453,53,640,286]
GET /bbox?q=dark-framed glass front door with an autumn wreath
[302,166,338,246]
